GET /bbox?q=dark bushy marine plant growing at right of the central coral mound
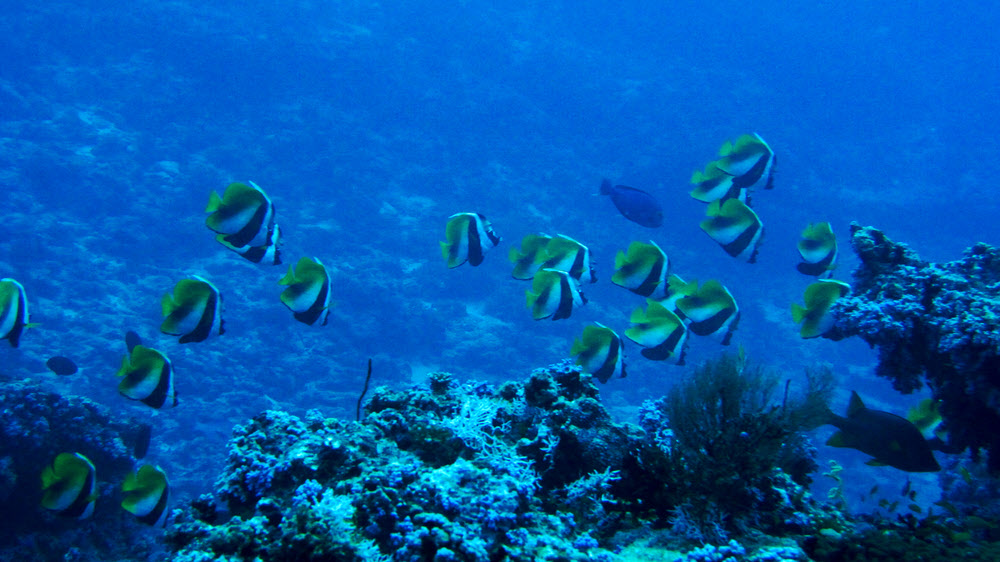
[616,352,833,543]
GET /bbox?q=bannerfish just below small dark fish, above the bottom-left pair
[118,345,177,409]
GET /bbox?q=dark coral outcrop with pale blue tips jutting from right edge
[826,224,1000,472]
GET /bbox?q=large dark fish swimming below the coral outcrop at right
[826,391,941,472]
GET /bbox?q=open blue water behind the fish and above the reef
[0,0,1000,560]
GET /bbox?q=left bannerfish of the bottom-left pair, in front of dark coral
[42,453,97,519]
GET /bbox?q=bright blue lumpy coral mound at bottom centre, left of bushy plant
[168,364,629,560]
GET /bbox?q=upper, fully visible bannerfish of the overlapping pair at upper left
[205,182,274,249]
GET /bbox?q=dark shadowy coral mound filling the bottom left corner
[0,380,158,560]
